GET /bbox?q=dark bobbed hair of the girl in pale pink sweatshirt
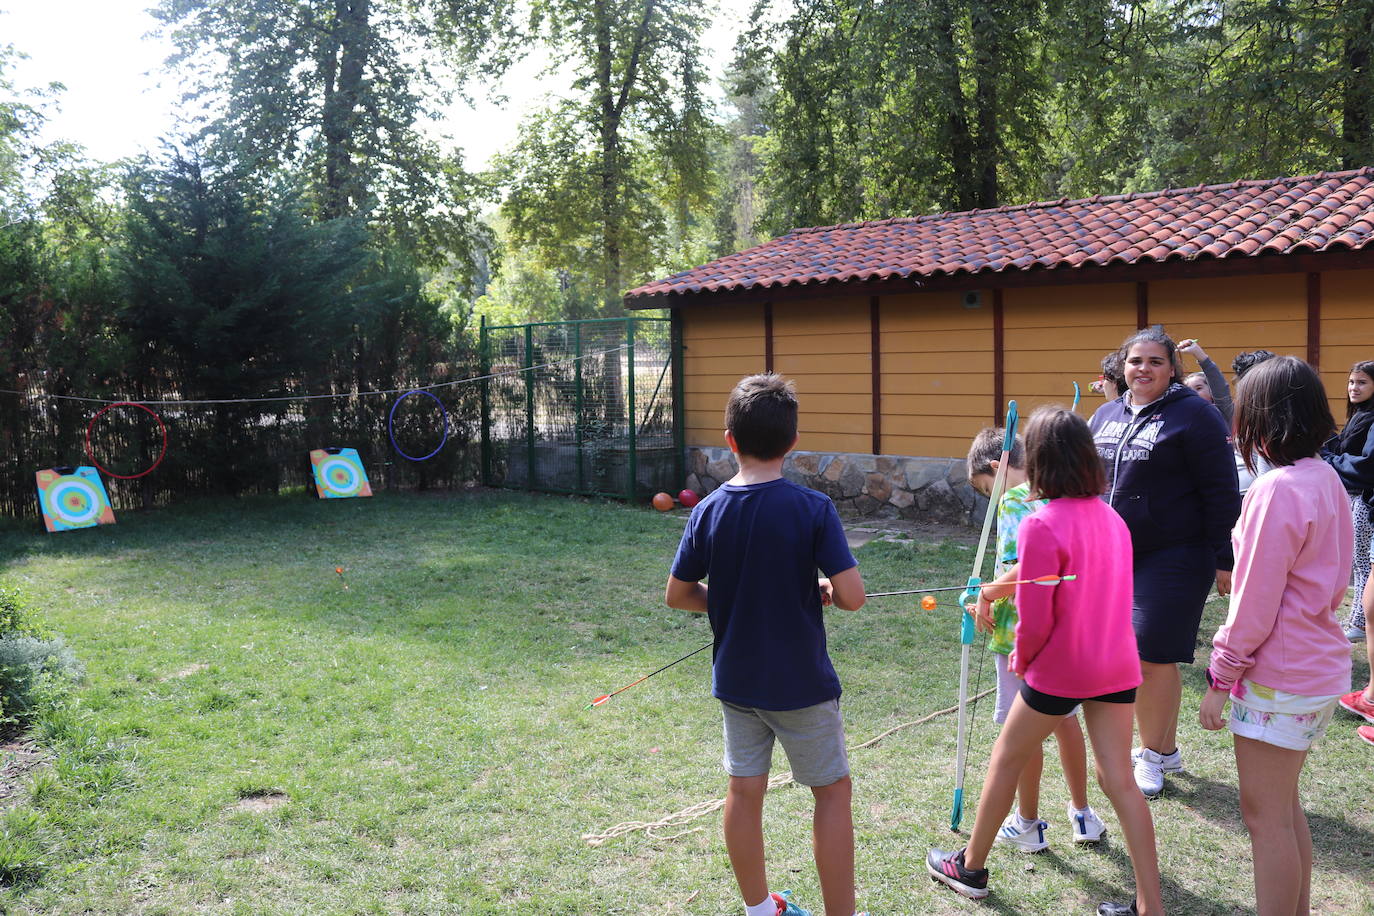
[1235,356,1336,472]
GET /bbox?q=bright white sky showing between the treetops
[0,0,750,169]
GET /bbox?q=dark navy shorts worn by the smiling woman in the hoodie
[1131,544,1216,665]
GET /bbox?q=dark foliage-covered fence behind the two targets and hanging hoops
[0,365,480,518]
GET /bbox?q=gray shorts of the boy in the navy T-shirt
[720,699,849,786]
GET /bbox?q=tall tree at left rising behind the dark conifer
[154,0,510,271]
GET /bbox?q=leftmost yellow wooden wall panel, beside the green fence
[682,305,765,446]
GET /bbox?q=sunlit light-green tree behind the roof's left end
[502,0,714,314]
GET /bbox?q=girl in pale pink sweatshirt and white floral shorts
[1198,356,1353,916]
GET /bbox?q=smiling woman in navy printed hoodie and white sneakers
[1091,327,1241,798]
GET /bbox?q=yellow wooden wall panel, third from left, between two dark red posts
[884,293,993,457]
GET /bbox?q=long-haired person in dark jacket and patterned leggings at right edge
[1322,361,1374,643]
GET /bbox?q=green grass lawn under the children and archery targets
[0,493,1374,916]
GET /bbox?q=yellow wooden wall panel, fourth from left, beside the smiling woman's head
[1005,283,1136,417]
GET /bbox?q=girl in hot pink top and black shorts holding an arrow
[926,408,1164,916]
